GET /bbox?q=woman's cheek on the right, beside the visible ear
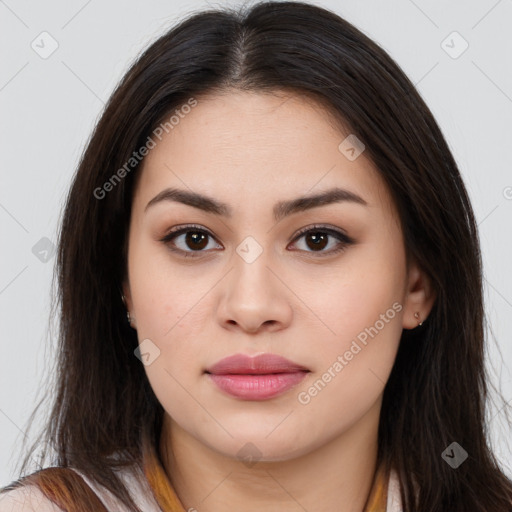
[301,234,405,406]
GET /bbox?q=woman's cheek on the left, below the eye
[129,241,212,392]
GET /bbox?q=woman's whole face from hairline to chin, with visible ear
[124,92,429,460]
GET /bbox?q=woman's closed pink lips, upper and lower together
[206,354,309,400]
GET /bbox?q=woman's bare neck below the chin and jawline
[160,400,381,512]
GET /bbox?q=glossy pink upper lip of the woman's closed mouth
[206,354,309,375]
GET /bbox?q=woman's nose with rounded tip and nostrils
[217,252,293,334]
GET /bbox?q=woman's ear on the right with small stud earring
[402,262,436,329]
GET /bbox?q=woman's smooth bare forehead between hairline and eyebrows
[132,91,393,219]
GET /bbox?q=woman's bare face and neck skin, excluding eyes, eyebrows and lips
[123,91,434,512]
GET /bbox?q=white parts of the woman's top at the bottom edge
[0,468,402,512]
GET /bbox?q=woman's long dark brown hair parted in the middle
[1,1,512,512]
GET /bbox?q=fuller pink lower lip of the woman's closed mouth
[208,371,307,400]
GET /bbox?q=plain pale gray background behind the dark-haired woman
[0,0,512,485]
